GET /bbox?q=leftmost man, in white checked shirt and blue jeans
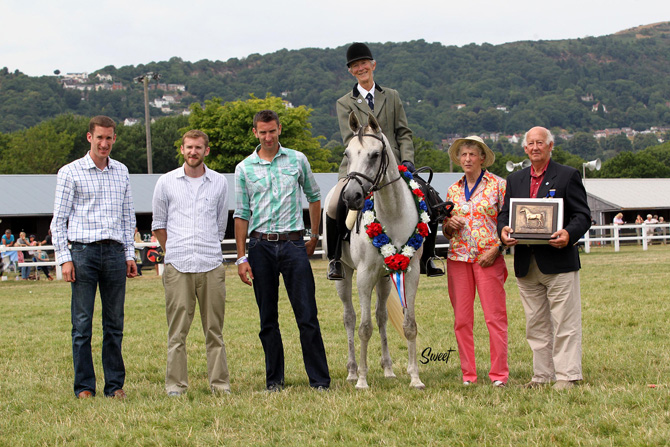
[51,116,137,399]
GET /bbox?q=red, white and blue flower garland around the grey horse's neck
[361,165,430,307]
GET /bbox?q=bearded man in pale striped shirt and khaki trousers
[151,130,230,397]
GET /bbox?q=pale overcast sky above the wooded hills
[0,0,670,76]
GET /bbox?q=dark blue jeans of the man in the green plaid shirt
[248,238,330,387]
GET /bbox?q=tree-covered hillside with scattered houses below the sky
[0,22,670,143]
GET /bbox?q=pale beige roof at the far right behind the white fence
[584,178,670,210]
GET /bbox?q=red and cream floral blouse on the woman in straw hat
[447,171,507,263]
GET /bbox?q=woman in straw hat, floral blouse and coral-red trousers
[443,136,509,387]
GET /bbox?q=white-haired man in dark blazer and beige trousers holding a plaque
[498,127,591,390]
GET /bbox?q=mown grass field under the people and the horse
[0,246,670,447]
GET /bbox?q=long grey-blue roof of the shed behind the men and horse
[0,173,463,216]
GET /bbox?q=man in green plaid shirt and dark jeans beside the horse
[233,110,330,391]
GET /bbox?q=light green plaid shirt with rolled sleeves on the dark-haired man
[233,145,321,233]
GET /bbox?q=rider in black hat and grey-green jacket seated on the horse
[326,42,444,280]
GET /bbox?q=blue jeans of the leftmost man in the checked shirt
[71,242,126,396]
